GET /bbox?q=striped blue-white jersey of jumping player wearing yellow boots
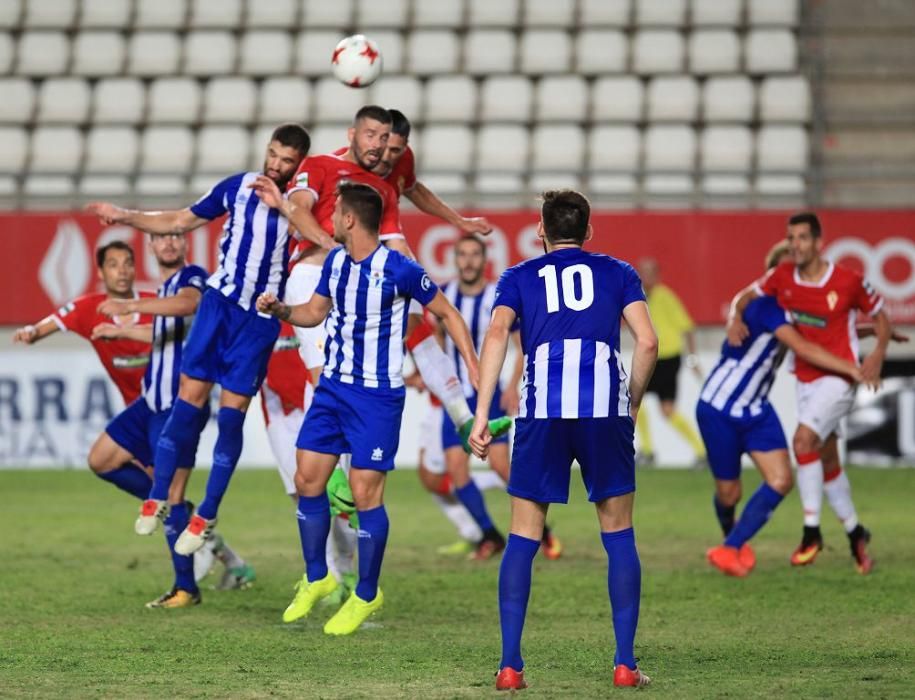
[315,245,438,392]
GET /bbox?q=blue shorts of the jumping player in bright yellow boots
[296,377,406,472]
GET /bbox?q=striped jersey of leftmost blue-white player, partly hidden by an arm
[143,265,207,413]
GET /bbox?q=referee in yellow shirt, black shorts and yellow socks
[637,258,705,465]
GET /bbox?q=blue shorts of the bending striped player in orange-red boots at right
[696,401,788,481]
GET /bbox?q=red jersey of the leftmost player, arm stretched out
[51,292,156,404]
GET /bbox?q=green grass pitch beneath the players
[0,470,915,698]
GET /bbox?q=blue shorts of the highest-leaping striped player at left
[181,289,280,396]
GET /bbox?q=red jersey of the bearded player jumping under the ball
[287,151,403,259]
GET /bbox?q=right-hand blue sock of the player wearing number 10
[600,527,642,669]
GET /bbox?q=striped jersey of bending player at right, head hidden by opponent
[699,297,791,418]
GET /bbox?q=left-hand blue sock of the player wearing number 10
[498,536,540,671]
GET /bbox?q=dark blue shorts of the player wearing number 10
[508,416,635,503]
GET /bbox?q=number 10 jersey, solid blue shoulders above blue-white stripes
[495,248,645,418]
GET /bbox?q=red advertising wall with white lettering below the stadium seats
[0,210,915,325]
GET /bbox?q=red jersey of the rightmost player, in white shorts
[757,262,883,382]
